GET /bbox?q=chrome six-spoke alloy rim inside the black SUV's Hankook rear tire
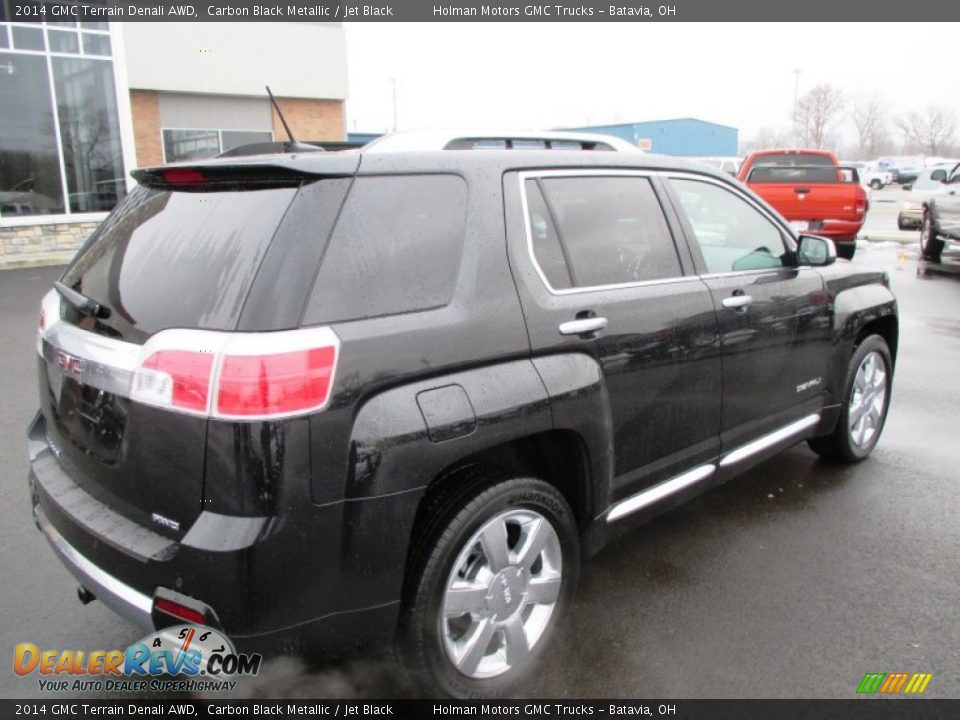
[440,509,563,679]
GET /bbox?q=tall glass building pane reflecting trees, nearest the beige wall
[52,58,126,212]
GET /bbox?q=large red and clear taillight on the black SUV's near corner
[131,327,340,420]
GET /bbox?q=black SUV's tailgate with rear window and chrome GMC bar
[37,177,297,537]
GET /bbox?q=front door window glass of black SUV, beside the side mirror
[670,178,784,273]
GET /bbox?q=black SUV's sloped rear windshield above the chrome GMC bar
[63,187,297,342]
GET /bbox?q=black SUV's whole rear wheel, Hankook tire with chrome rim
[398,471,580,698]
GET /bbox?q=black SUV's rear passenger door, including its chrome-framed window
[504,170,720,500]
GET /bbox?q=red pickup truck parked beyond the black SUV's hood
[737,150,869,260]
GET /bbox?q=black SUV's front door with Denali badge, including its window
[666,174,831,453]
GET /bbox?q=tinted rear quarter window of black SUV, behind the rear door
[304,175,467,325]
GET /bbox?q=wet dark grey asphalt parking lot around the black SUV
[0,231,960,699]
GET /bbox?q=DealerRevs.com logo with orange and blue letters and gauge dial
[13,625,263,692]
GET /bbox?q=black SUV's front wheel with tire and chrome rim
[807,335,893,463]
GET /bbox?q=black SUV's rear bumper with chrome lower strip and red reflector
[28,415,419,656]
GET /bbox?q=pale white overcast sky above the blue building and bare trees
[345,22,960,146]
